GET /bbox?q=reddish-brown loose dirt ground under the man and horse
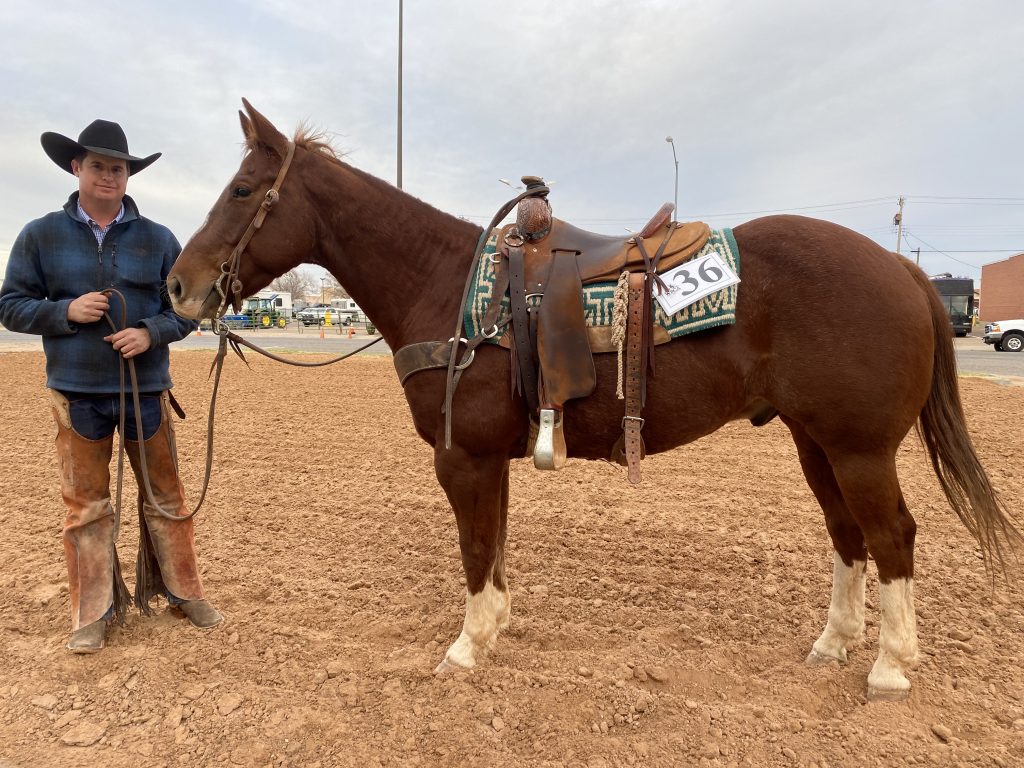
[0,351,1024,768]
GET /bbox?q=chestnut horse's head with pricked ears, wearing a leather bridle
[167,99,315,319]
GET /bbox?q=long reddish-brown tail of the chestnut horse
[905,261,1024,573]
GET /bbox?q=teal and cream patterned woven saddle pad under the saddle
[463,228,739,344]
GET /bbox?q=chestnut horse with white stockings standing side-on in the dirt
[167,101,1021,699]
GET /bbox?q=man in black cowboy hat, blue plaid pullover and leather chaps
[0,120,223,653]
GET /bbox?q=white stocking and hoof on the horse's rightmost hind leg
[867,579,918,699]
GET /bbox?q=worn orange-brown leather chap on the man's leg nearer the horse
[125,393,204,609]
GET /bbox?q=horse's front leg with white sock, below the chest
[434,445,511,672]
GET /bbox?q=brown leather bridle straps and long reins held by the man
[109,141,384,539]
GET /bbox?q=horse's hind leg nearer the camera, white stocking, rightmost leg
[831,450,918,700]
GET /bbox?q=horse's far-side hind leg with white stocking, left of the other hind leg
[782,417,867,665]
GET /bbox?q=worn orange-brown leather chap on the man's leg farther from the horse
[53,393,120,634]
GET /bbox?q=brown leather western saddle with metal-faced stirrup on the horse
[493,176,711,477]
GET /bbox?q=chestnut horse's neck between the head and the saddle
[310,163,480,348]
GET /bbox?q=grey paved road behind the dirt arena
[0,328,1024,383]
